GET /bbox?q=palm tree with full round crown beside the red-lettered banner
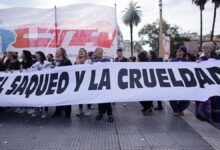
[122,1,142,56]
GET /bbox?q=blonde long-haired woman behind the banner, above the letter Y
[74,48,91,117]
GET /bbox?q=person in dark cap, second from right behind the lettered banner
[170,46,189,116]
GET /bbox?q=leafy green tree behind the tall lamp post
[139,20,189,56]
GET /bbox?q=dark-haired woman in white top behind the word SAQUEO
[31,51,50,118]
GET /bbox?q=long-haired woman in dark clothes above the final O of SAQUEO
[53,47,72,118]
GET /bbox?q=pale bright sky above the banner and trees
[0,0,220,46]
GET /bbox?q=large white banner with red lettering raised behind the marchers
[0,4,118,57]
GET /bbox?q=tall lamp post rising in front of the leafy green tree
[159,0,163,58]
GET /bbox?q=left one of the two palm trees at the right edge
[192,0,208,49]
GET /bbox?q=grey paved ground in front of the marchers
[0,103,220,150]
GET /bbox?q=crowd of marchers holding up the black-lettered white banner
[0,42,220,122]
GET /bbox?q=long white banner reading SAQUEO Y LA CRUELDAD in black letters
[0,61,220,106]
